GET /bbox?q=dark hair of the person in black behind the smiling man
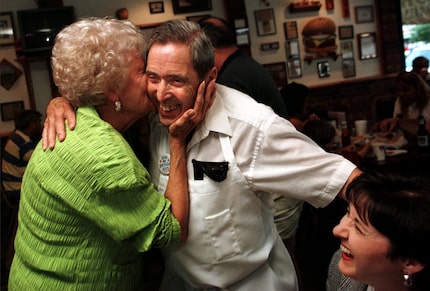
[199,16,236,48]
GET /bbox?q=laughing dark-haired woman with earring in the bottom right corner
[327,172,430,291]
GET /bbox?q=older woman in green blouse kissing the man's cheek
[8,18,214,291]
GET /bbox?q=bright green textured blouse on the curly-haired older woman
[9,107,180,291]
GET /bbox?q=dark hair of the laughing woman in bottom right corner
[346,172,430,290]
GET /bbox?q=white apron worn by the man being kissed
[151,126,298,291]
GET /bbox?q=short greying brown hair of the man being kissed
[145,19,214,79]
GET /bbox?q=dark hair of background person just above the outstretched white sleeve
[302,119,336,149]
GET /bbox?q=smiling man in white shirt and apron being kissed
[43,20,361,290]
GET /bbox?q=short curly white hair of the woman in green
[51,17,146,106]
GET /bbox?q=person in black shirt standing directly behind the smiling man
[199,16,288,118]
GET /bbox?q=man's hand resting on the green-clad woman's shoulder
[42,97,76,150]
